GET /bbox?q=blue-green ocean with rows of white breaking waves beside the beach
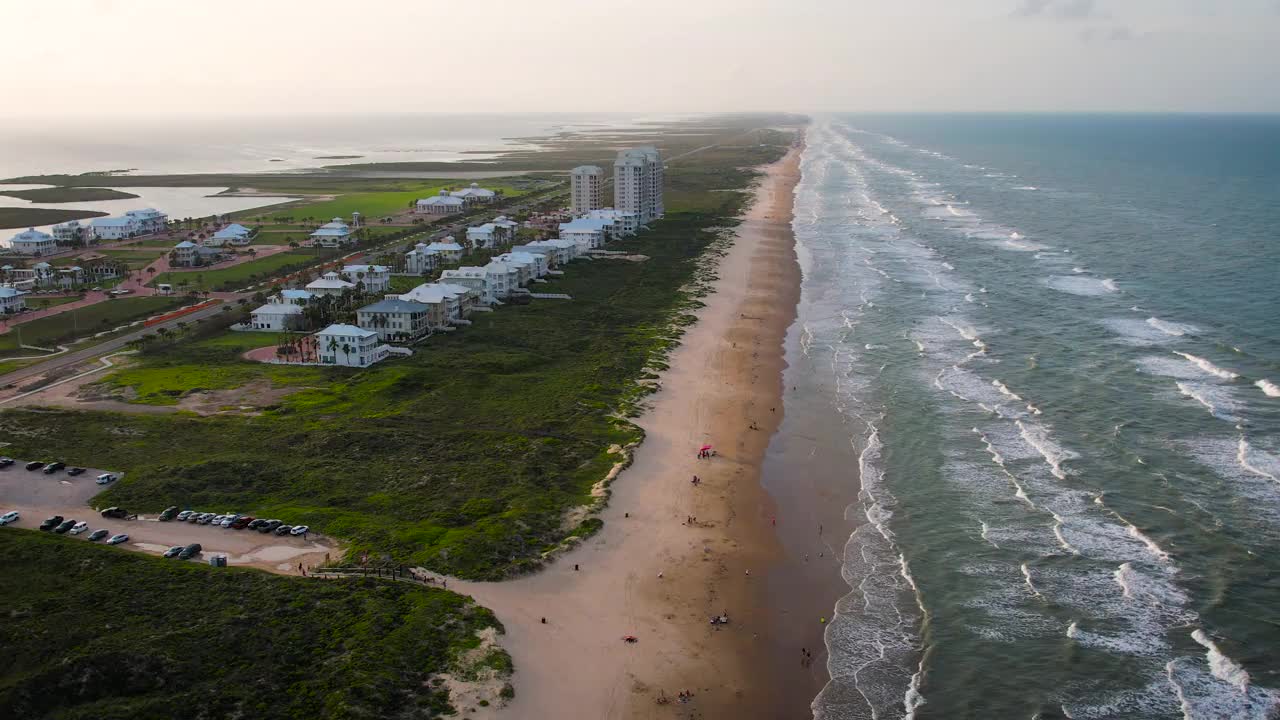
[786,115,1280,720]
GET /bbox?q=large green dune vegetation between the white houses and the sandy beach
[0,116,790,578]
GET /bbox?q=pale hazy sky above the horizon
[0,0,1280,118]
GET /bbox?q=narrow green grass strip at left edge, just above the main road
[0,297,188,357]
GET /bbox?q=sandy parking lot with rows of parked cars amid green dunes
[0,457,342,574]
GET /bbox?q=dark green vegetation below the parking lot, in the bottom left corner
[0,528,509,720]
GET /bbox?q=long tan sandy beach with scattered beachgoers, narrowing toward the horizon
[424,141,820,719]
